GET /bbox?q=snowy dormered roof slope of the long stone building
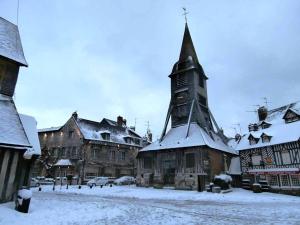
[76,118,142,146]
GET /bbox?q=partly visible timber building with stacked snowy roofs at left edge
[0,17,40,203]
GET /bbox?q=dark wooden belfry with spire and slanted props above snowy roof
[161,23,223,140]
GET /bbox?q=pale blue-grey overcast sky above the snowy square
[0,0,300,138]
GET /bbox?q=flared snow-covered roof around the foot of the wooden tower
[140,123,236,154]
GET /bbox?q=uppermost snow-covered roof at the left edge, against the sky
[0,17,27,66]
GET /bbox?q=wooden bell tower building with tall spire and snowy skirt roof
[137,24,236,191]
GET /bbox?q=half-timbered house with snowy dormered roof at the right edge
[232,102,300,194]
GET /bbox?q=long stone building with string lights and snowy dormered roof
[34,112,145,181]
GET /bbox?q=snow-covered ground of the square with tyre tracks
[0,186,300,225]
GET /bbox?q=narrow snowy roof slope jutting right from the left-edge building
[19,114,41,157]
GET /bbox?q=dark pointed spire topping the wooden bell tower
[179,23,198,63]
